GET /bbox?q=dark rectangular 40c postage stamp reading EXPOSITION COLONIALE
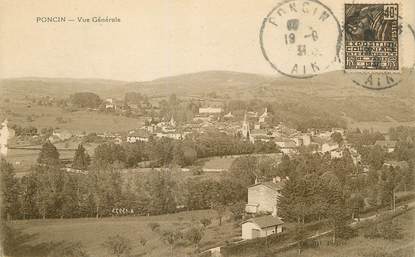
[345,4,400,72]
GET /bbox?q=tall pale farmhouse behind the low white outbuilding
[245,177,285,213]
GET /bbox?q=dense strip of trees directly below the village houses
[95,132,279,168]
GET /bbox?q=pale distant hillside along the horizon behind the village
[0,70,415,125]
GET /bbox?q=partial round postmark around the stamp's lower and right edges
[345,22,415,90]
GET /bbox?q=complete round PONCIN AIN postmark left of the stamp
[260,0,342,78]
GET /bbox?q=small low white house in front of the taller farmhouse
[242,215,284,240]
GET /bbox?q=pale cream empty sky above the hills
[0,0,415,81]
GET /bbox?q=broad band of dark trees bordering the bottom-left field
[0,136,278,219]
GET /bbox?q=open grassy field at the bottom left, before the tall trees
[11,210,241,257]
